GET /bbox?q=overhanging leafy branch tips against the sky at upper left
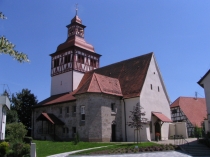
[0,12,29,62]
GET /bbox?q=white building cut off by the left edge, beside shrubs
[0,94,10,140]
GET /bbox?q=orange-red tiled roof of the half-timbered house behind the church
[170,97,207,127]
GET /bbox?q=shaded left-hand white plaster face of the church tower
[51,71,73,95]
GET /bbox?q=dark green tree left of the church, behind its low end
[11,89,38,129]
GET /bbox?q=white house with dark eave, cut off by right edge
[198,70,210,132]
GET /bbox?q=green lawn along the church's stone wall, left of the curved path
[33,140,113,157]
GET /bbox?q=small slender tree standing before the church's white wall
[127,103,147,143]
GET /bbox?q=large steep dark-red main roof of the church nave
[76,53,153,98]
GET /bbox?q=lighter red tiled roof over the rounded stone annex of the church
[76,73,122,96]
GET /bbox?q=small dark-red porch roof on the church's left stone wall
[36,113,65,125]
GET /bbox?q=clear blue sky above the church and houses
[0,0,210,102]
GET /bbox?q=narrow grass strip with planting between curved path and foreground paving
[72,142,159,155]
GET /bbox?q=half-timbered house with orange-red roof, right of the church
[170,97,207,137]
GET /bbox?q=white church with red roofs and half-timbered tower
[32,14,172,142]
